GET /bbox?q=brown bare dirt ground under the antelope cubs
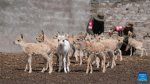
[0,53,150,84]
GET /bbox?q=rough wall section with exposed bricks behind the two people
[91,0,150,54]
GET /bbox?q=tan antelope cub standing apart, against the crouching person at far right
[128,31,147,57]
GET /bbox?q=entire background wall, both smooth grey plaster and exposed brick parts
[0,0,150,52]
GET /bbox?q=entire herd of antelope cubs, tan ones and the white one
[14,30,147,74]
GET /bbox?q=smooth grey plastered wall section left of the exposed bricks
[0,0,90,52]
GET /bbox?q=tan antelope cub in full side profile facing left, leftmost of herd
[14,34,53,73]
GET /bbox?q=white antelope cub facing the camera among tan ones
[56,33,70,73]
